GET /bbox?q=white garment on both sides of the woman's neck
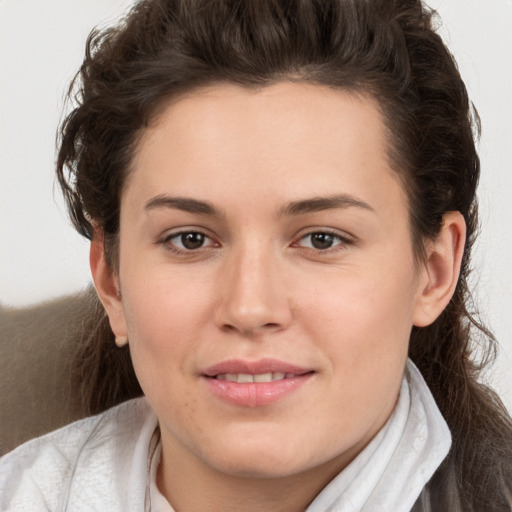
[0,361,451,512]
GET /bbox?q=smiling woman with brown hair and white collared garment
[1,0,512,511]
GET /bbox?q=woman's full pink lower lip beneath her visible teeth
[204,373,313,407]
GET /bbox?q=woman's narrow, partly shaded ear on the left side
[89,229,128,347]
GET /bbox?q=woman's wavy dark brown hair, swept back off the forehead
[57,0,512,510]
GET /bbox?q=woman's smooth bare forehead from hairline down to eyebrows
[127,82,404,212]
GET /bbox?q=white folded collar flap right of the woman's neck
[307,360,451,512]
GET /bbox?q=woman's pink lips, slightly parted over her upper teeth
[202,359,314,407]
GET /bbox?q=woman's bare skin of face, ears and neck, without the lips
[91,82,464,511]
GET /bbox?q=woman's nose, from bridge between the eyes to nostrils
[216,243,292,337]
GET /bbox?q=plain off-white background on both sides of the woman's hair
[0,0,512,410]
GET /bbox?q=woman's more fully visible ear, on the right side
[413,212,466,327]
